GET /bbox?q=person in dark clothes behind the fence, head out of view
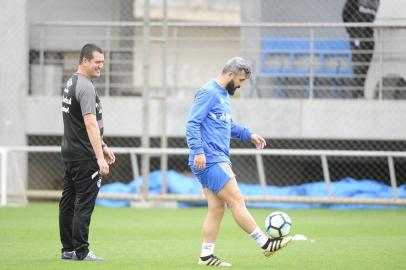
[342,0,379,97]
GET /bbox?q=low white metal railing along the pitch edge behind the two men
[0,146,406,206]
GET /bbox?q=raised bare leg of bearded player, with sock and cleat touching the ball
[217,177,292,256]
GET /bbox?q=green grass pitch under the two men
[0,203,406,270]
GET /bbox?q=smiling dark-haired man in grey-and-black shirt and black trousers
[59,44,115,261]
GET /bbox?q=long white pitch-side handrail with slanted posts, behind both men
[0,146,406,206]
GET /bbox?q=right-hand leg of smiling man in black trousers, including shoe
[72,160,103,261]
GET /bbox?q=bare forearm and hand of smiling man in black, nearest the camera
[83,113,109,175]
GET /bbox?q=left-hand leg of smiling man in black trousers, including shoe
[59,162,75,260]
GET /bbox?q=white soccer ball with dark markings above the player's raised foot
[265,212,292,238]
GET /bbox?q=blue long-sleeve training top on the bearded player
[186,80,251,166]
